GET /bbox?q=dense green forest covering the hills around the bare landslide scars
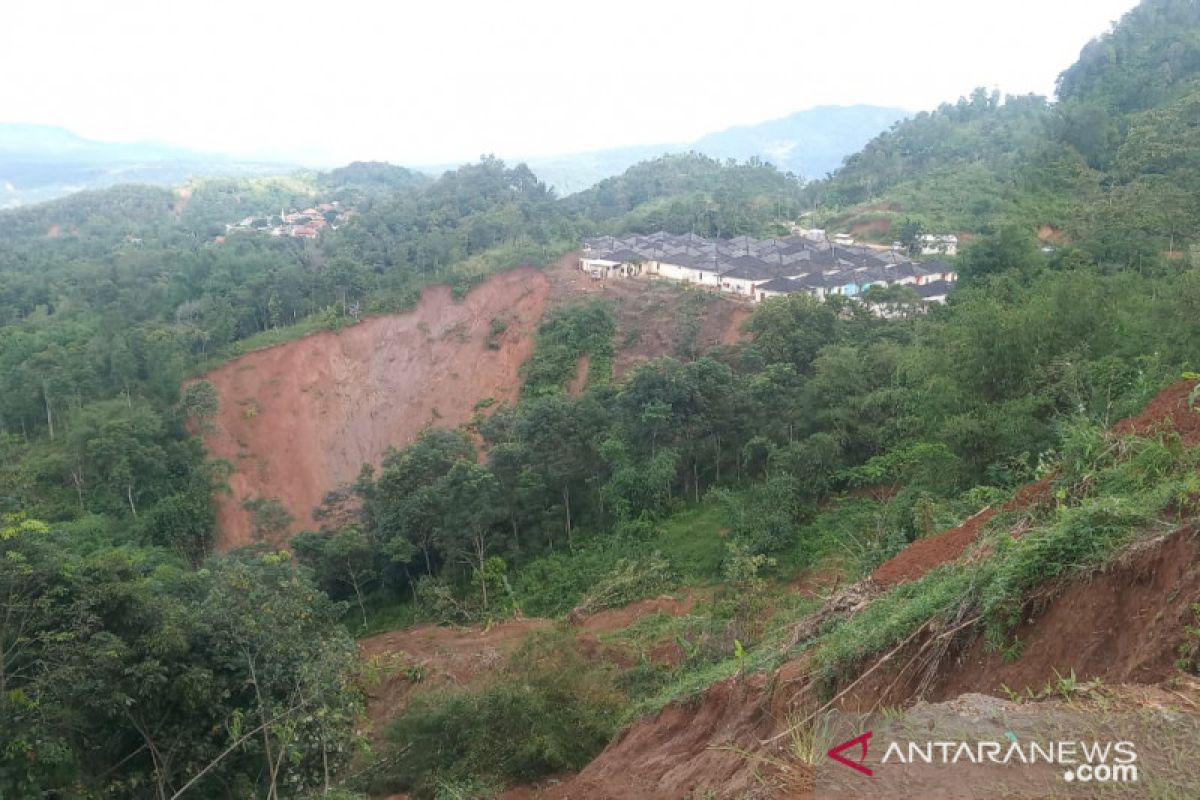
[7,0,1200,798]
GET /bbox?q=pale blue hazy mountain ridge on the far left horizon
[0,122,295,209]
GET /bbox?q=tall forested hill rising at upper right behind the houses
[808,0,1200,271]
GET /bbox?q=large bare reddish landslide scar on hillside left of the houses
[205,269,550,549]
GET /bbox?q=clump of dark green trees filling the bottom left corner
[0,518,360,798]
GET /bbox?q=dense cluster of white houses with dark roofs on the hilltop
[580,231,958,302]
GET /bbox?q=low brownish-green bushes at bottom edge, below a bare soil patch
[373,631,623,798]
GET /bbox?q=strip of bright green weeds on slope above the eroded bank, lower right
[806,425,1200,690]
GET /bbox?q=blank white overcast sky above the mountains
[0,0,1135,164]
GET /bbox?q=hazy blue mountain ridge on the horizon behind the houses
[514,104,908,194]
